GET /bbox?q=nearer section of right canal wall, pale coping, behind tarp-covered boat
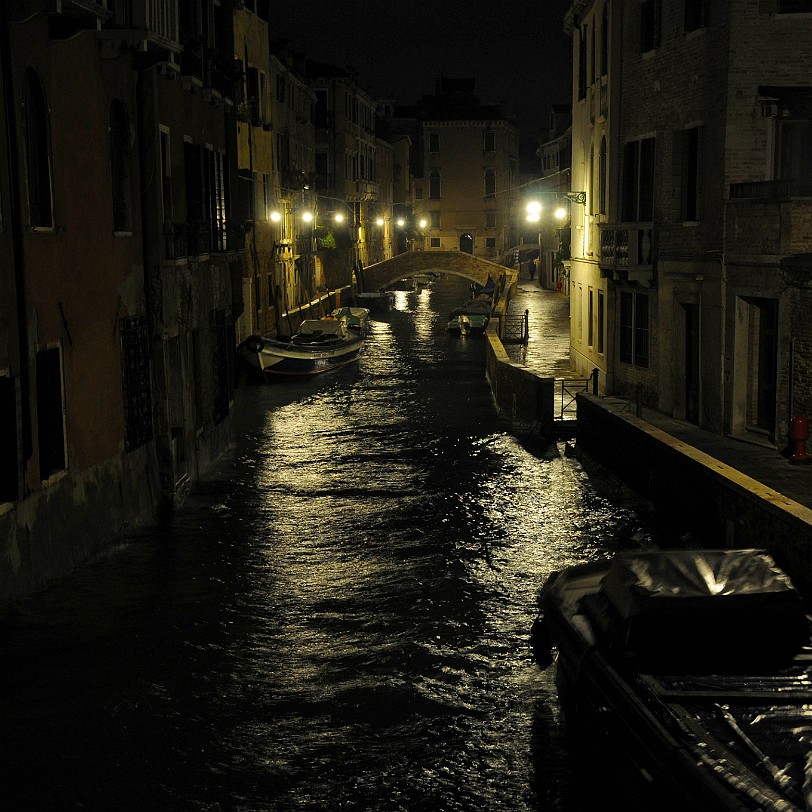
[576,394,812,598]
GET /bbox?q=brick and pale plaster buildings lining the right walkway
[565,0,812,450]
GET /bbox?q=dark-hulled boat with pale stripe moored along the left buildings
[238,319,364,376]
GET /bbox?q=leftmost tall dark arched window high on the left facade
[23,68,54,228]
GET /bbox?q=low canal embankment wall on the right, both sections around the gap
[485,318,812,599]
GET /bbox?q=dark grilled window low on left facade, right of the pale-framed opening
[119,316,152,451]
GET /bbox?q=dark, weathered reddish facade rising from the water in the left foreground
[0,0,242,599]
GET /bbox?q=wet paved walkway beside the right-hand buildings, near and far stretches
[505,279,812,509]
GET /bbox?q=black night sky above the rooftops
[270,0,571,139]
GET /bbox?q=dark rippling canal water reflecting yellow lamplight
[0,280,648,812]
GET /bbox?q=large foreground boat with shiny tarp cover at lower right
[531,549,812,812]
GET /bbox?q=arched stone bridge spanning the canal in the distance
[359,251,517,292]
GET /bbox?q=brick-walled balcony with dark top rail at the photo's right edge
[726,180,812,258]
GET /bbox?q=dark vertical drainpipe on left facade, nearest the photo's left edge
[0,3,32,488]
